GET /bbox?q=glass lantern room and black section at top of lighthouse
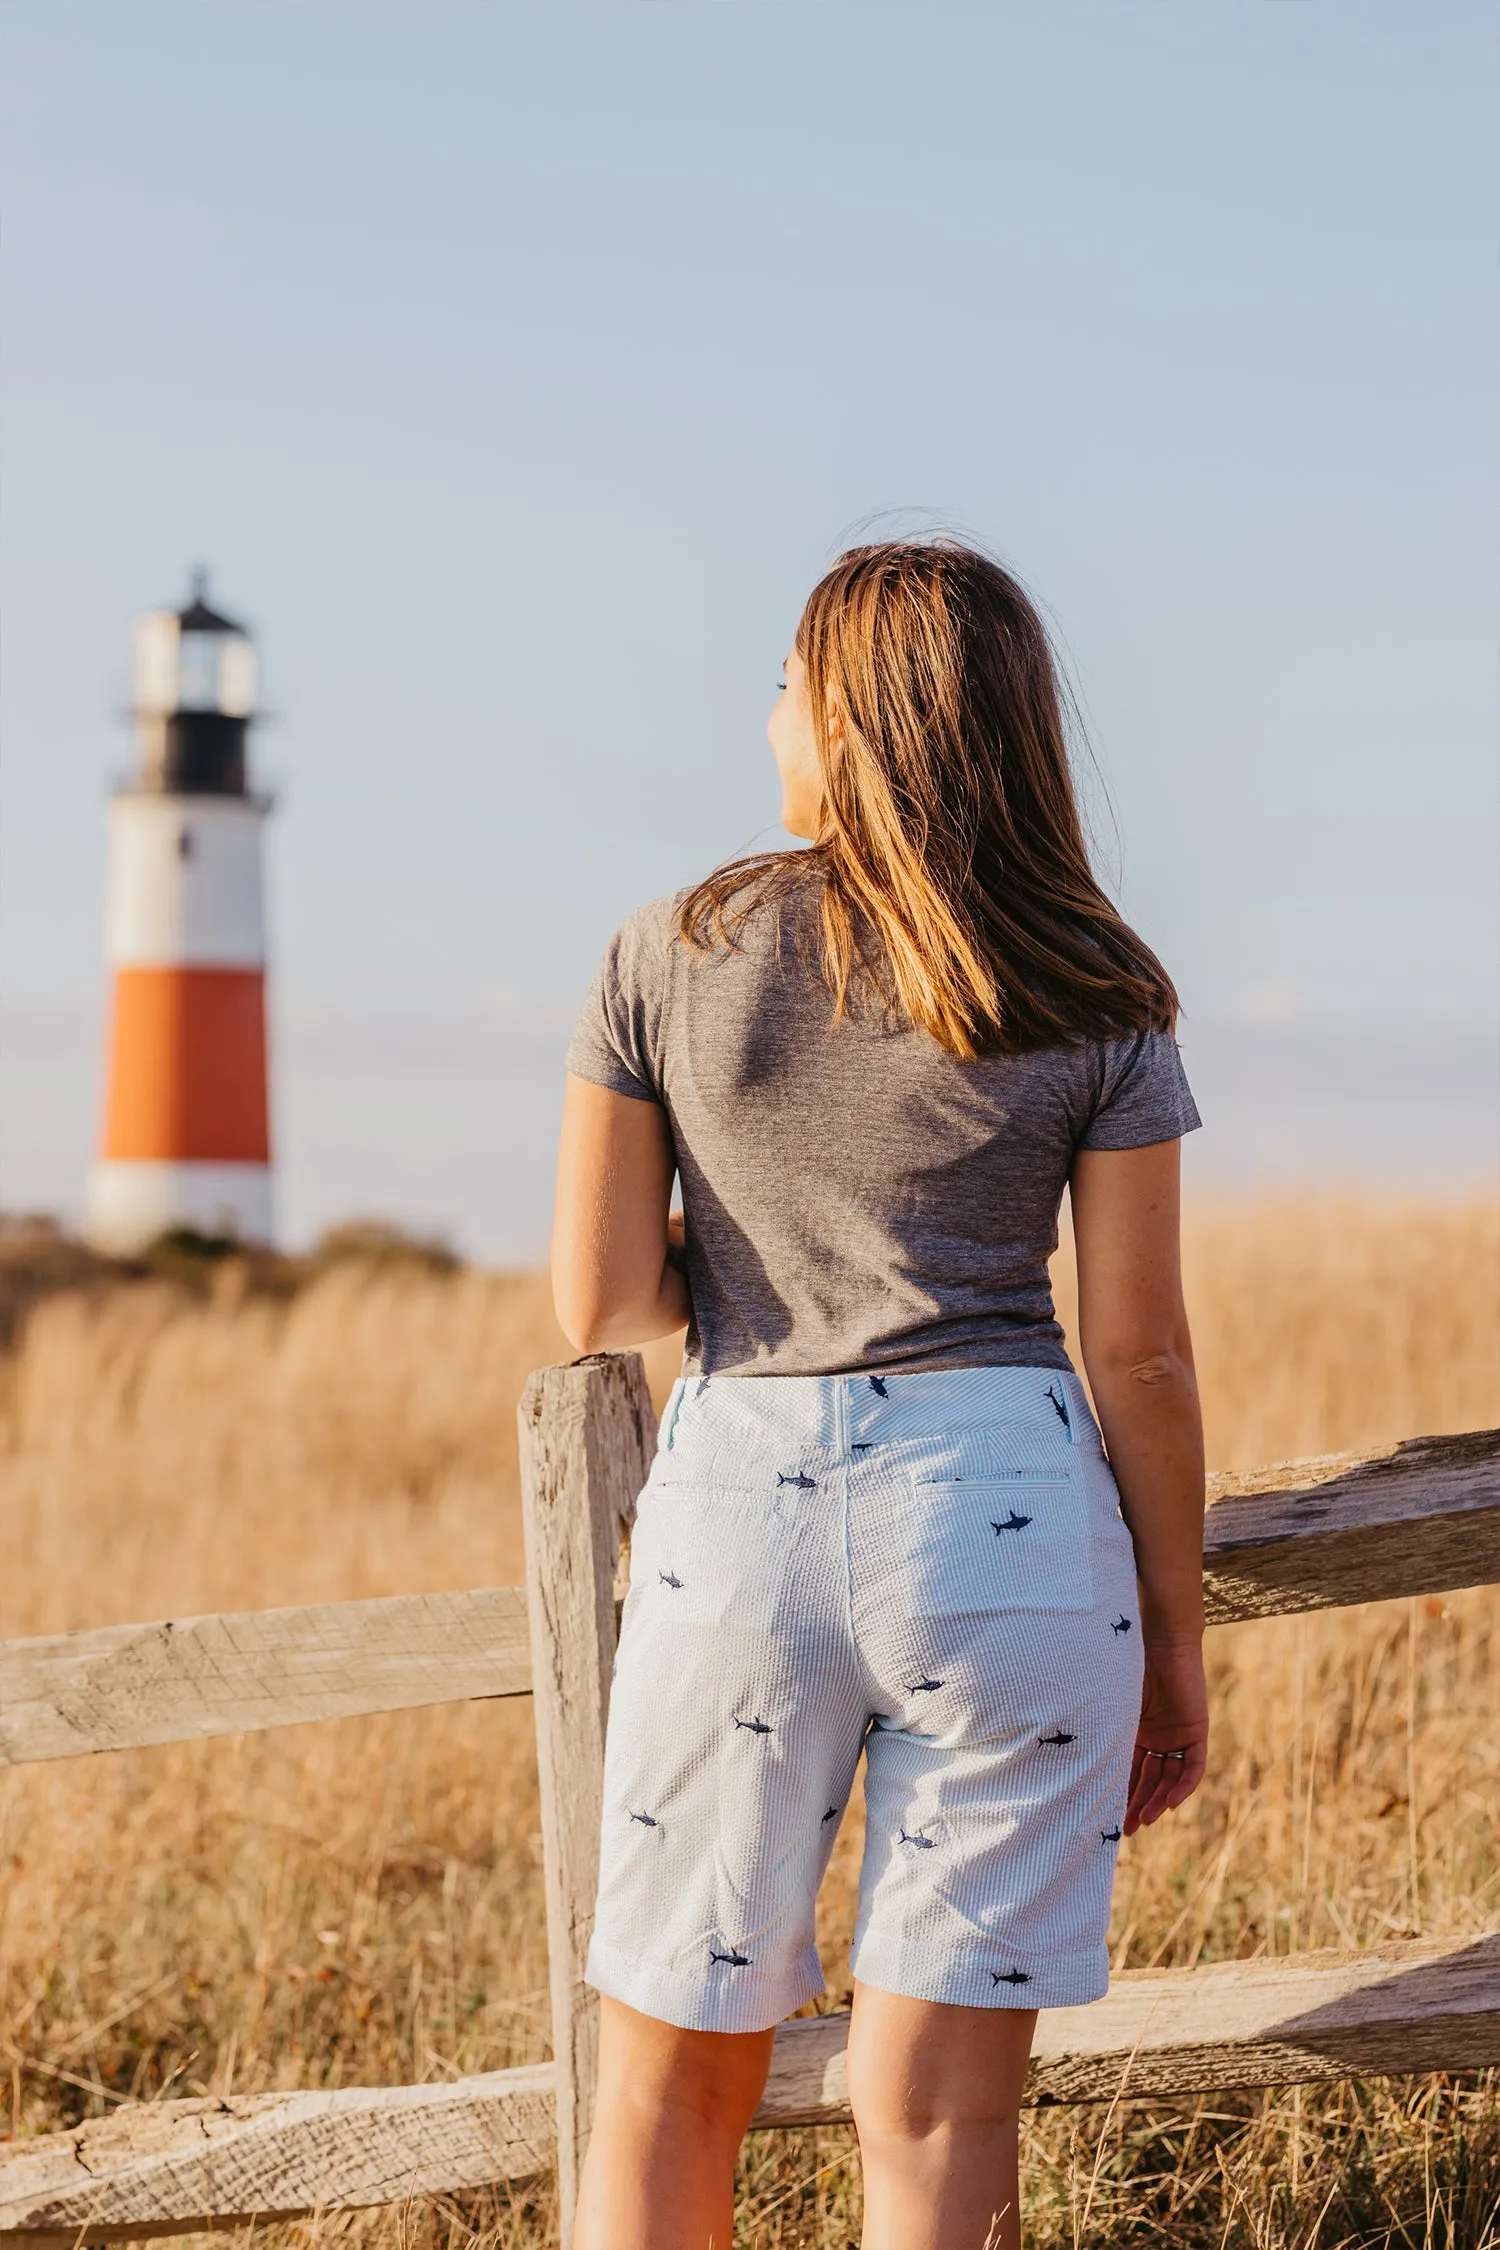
[135,572,256,797]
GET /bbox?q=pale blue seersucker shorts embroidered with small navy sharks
[587,1368,1140,2032]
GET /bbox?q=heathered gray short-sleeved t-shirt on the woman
[567,887,1199,1375]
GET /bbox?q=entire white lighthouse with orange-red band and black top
[85,576,272,1253]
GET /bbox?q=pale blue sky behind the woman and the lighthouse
[0,0,1500,1256]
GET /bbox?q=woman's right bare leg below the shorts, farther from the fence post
[848,1985,1037,2250]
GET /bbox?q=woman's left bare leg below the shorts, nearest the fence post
[573,1998,776,2250]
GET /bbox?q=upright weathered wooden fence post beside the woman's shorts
[519,1352,657,2250]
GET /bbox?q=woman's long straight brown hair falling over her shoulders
[679,538,1176,1058]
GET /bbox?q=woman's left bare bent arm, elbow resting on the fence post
[551,1078,688,1352]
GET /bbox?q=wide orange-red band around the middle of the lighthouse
[103,968,270,1163]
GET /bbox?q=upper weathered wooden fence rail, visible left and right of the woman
[0,1422,1500,1766]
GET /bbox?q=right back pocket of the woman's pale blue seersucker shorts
[911,1467,1093,1618]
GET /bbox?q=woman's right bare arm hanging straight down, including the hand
[1070,1141,1208,1832]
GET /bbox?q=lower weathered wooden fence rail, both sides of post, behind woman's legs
[0,1937,1500,2250]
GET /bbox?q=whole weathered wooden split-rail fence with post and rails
[0,1352,1500,2250]
